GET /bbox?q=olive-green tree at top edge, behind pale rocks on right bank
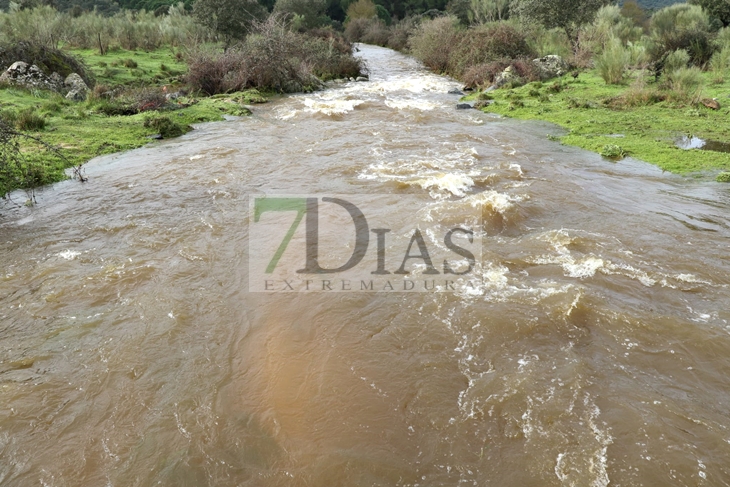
[510,0,610,46]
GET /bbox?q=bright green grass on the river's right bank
[471,70,730,175]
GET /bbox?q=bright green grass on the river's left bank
[0,45,266,198]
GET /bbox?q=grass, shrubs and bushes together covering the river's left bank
[0,0,363,198]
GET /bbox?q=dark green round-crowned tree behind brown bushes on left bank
[193,0,268,48]
